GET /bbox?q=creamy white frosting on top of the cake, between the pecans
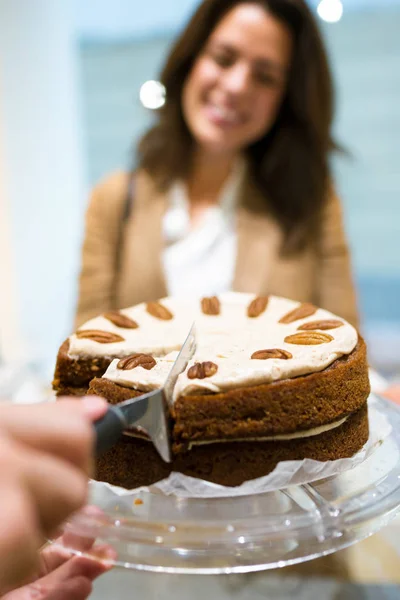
[69,292,358,399]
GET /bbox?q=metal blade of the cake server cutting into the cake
[94,323,196,462]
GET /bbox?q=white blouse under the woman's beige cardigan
[162,160,245,297]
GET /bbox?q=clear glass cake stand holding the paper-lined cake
[53,399,400,574]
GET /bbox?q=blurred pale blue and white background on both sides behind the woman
[0,0,400,378]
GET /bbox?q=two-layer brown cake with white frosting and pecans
[53,292,370,488]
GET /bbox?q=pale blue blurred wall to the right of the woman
[325,10,400,328]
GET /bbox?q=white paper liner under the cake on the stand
[92,396,392,501]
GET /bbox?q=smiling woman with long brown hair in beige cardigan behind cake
[76,0,357,325]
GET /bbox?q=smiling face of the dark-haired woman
[182,4,292,154]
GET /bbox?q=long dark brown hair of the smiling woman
[137,0,336,251]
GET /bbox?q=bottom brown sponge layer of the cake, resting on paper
[96,404,369,489]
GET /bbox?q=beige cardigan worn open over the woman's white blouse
[76,172,357,326]
